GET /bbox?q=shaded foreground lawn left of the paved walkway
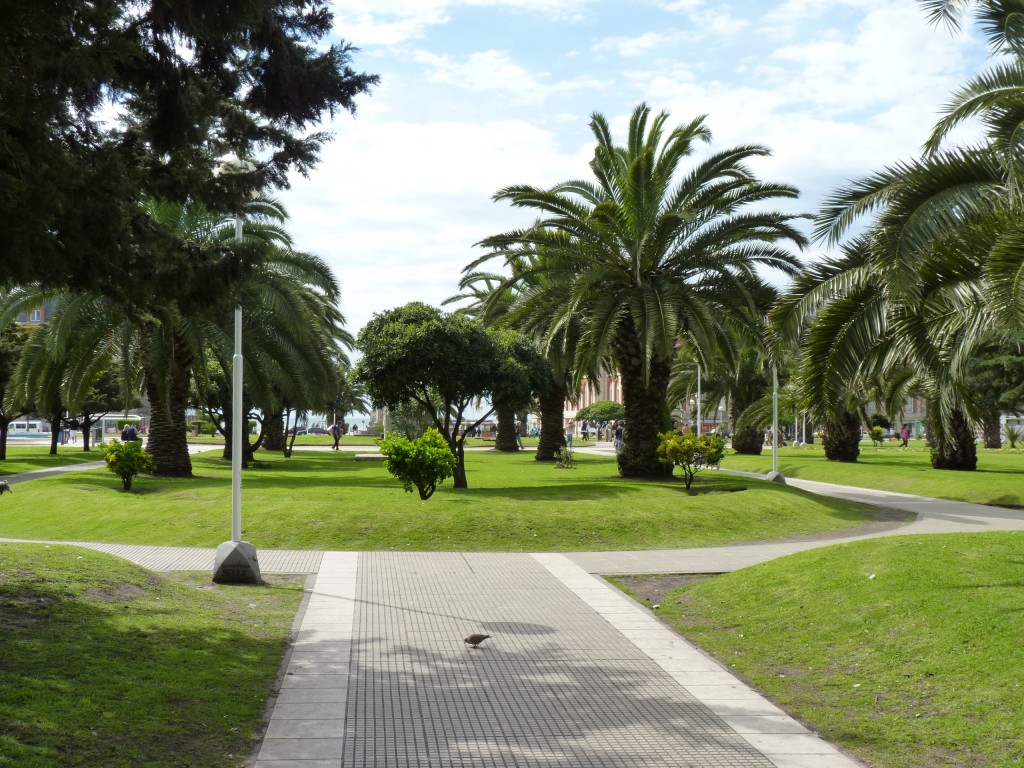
[0,544,302,768]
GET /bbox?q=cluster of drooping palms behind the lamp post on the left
[0,197,362,476]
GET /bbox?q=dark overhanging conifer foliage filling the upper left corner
[0,0,377,294]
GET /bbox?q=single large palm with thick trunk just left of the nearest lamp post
[7,193,351,476]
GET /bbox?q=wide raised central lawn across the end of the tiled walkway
[0,451,878,552]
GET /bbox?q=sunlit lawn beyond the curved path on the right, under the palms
[722,440,1024,507]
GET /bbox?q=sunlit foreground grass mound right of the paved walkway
[634,532,1024,768]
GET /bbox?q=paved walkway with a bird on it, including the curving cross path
[0,446,1024,768]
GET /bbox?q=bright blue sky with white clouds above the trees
[281,0,987,342]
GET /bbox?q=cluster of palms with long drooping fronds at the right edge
[773,0,1024,469]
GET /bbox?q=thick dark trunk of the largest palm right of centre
[614,321,672,478]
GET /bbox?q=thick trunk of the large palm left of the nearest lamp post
[143,339,193,477]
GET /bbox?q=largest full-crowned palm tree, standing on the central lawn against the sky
[476,104,805,476]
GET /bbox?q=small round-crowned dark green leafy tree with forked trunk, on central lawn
[356,302,501,488]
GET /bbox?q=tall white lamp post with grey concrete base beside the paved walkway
[213,158,261,584]
